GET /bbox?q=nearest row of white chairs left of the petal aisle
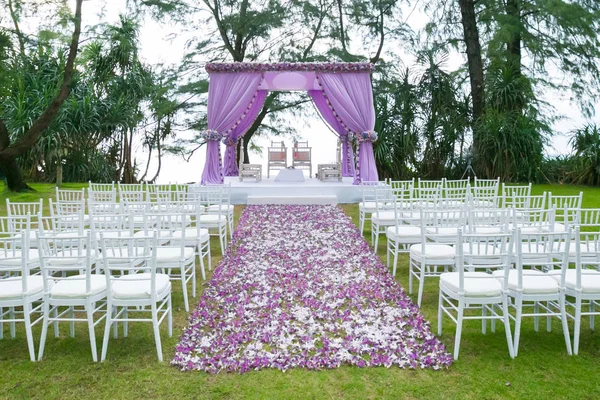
[0,216,178,361]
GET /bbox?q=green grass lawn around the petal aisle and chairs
[0,185,600,399]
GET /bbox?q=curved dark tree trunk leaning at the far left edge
[0,0,83,191]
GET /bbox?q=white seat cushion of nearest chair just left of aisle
[111,273,171,300]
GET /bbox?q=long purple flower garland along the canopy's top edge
[205,62,374,73]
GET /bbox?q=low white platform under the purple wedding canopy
[225,176,362,204]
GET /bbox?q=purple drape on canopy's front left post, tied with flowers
[201,72,262,184]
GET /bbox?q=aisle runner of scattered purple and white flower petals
[172,205,452,373]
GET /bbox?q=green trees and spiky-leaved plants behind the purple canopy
[0,0,600,190]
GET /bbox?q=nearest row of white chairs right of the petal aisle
[438,227,600,359]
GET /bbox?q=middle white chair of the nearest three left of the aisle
[38,231,107,361]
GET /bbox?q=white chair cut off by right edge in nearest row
[564,227,600,355]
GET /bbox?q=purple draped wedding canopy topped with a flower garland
[201,63,378,184]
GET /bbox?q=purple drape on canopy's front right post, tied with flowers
[318,72,379,184]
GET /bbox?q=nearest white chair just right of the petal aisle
[438,229,514,359]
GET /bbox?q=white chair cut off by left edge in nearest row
[0,216,44,361]
